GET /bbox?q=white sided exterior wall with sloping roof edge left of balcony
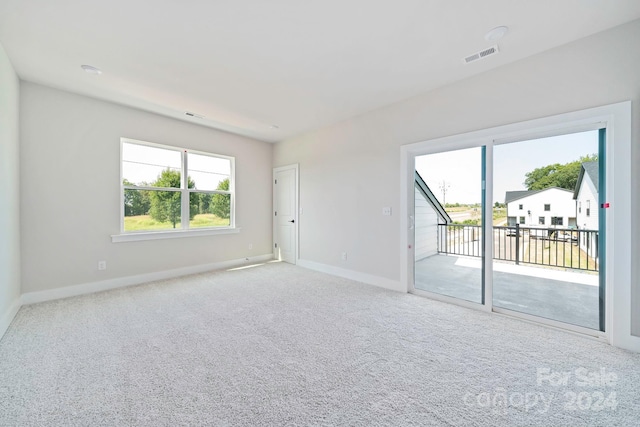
[414,172,451,261]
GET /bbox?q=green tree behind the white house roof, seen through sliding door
[524,154,598,190]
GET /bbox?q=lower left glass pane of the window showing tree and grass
[124,189,180,231]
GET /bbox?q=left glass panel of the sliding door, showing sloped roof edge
[414,147,485,304]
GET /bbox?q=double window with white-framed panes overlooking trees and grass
[121,138,235,232]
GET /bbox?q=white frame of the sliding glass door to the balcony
[400,101,640,351]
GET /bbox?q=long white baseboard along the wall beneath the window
[18,254,273,308]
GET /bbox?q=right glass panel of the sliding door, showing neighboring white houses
[493,130,604,330]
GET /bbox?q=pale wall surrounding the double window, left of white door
[20,83,273,293]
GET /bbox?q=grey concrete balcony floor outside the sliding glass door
[415,255,599,330]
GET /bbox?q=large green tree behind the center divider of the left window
[149,168,198,228]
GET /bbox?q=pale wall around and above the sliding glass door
[274,21,640,335]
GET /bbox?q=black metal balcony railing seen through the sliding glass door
[438,224,599,271]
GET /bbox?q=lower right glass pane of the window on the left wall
[189,192,231,228]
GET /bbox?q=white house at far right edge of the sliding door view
[573,162,599,258]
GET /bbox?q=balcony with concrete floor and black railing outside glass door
[415,224,600,330]
